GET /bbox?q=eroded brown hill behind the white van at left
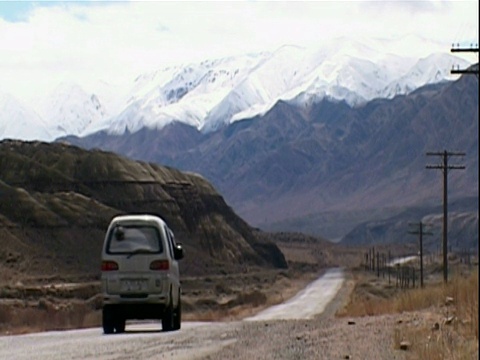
[0,140,286,280]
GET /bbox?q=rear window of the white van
[107,225,163,254]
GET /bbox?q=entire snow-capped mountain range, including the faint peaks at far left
[0,39,469,140]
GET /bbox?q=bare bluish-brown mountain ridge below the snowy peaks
[64,72,478,245]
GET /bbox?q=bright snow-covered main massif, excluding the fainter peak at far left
[114,40,464,133]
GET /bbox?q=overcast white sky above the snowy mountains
[0,1,479,105]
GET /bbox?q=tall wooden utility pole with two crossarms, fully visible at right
[427,150,465,282]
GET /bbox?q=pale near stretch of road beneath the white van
[0,322,238,360]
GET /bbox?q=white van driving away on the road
[101,215,183,334]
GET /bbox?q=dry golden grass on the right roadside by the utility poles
[337,269,479,360]
